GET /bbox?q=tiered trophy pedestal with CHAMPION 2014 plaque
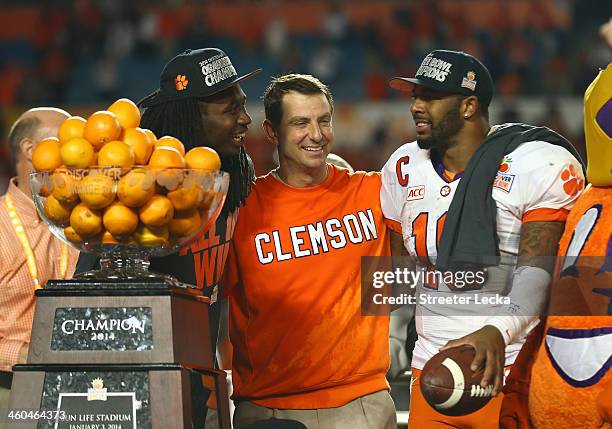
[7,280,230,429]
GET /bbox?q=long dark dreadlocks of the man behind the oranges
[140,98,255,214]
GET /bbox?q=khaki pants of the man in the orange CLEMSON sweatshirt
[234,390,397,429]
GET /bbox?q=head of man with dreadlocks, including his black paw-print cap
[138,48,261,216]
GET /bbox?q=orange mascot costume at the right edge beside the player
[500,63,612,429]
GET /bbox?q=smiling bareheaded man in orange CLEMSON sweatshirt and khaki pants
[224,74,396,429]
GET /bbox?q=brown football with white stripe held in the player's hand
[419,346,493,416]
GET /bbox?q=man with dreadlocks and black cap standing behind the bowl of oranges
[77,48,261,427]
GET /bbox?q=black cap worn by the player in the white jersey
[389,50,493,106]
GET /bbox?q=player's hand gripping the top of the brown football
[440,325,506,395]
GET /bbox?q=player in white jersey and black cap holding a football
[381,51,584,428]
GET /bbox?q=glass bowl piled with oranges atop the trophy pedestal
[30,99,229,280]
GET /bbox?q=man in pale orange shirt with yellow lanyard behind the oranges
[0,107,78,418]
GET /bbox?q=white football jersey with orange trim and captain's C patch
[381,136,584,369]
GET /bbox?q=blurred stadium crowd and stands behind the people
[0,0,612,192]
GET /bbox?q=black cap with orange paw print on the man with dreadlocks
[138,48,261,107]
